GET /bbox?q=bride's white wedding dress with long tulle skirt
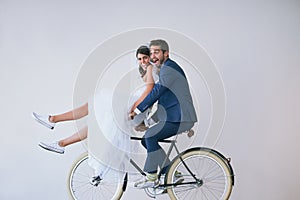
[88,67,158,182]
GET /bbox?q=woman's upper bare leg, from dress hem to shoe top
[49,103,88,123]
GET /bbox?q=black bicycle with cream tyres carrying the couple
[68,130,234,200]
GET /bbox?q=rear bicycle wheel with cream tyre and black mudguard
[167,148,233,200]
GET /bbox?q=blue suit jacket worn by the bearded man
[137,59,197,122]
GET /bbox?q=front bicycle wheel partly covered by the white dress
[68,153,123,200]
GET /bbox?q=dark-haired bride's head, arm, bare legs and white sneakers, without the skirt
[33,46,158,154]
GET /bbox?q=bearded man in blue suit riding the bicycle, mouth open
[131,39,197,188]
